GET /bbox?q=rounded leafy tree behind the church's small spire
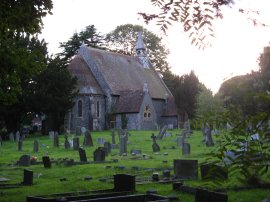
[105,24,169,73]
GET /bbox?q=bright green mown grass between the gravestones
[0,130,270,202]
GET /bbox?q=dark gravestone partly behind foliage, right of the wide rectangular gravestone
[200,164,228,180]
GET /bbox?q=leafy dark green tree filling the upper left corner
[0,0,52,105]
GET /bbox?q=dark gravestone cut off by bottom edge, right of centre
[195,189,228,202]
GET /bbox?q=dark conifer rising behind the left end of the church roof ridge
[58,25,104,63]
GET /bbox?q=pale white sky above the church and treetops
[40,0,270,93]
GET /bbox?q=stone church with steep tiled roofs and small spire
[65,32,178,131]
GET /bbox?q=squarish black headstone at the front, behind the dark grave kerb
[113,174,136,192]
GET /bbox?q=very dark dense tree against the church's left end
[31,57,77,131]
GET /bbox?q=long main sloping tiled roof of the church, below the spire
[79,46,171,99]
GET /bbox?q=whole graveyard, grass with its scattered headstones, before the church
[0,129,269,202]
